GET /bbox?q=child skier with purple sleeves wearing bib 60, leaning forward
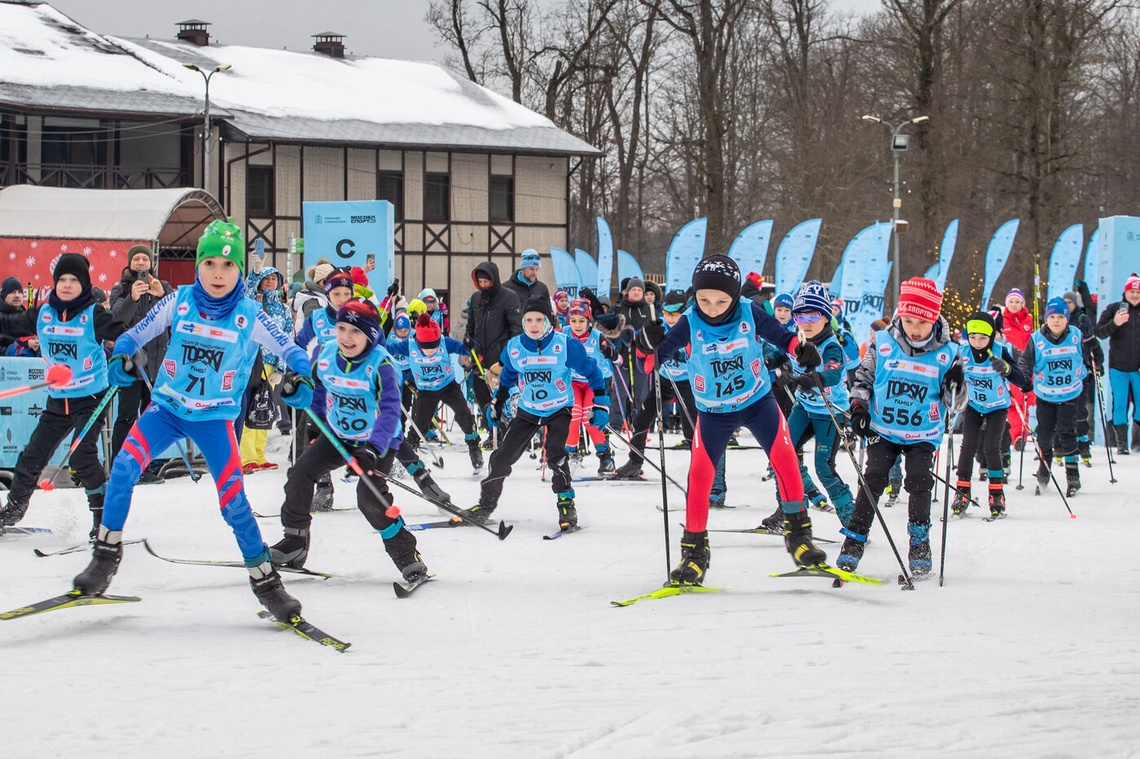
[269,300,428,582]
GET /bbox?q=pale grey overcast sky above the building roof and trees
[47,0,880,67]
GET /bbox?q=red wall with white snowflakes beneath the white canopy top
[0,237,149,300]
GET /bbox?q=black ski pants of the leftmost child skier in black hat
[8,390,111,507]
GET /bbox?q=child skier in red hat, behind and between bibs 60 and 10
[389,313,483,473]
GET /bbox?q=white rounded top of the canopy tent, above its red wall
[0,185,223,246]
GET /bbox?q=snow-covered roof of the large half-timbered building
[0,0,600,155]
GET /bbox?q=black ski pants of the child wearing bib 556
[848,435,934,536]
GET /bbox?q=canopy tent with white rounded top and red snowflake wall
[0,185,225,288]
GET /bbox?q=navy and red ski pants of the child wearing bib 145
[685,392,806,532]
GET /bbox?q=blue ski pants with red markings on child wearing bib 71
[103,402,268,558]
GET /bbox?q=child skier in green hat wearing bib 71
[74,220,312,621]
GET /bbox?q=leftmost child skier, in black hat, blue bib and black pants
[0,253,123,538]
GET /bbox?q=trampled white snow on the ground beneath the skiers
[0,433,1140,759]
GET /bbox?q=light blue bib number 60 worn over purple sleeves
[317,343,389,441]
